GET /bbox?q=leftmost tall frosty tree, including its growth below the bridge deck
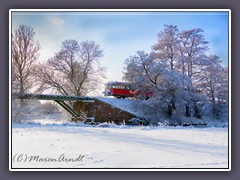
[11,25,40,121]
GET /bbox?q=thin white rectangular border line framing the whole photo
[9,9,232,171]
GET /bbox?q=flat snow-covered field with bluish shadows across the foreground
[12,120,228,169]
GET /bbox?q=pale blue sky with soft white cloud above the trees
[11,10,229,81]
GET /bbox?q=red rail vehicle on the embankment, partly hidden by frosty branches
[103,81,152,99]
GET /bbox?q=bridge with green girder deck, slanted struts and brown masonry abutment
[13,94,136,124]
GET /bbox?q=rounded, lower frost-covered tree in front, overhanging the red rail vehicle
[124,51,192,117]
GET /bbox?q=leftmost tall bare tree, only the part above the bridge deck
[12,25,40,93]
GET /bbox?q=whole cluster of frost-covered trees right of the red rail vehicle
[123,25,228,124]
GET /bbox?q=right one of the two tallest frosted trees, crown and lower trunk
[174,28,208,118]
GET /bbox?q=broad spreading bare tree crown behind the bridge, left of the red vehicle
[36,40,105,96]
